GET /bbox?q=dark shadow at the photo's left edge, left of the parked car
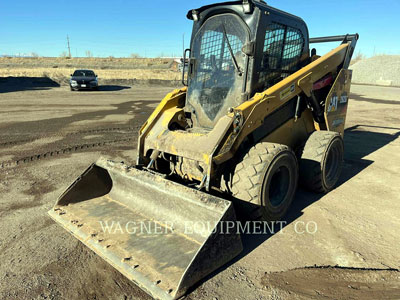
[0,77,60,93]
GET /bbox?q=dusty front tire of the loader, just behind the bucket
[231,143,298,221]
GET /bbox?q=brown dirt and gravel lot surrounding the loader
[0,82,400,300]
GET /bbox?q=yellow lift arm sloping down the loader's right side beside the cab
[214,34,358,163]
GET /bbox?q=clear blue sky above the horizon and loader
[0,0,400,57]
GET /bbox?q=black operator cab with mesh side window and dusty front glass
[185,0,309,128]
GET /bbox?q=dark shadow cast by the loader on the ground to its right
[188,125,400,290]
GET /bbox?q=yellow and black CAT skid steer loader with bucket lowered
[49,0,358,299]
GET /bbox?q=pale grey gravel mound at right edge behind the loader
[350,55,400,87]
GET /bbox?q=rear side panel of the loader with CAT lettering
[324,69,352,136]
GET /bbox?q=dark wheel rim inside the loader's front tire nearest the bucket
[268,166,290,207]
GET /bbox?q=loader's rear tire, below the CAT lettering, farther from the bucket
[300,131,344,193]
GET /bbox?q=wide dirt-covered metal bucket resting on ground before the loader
[49,159,242,299]
